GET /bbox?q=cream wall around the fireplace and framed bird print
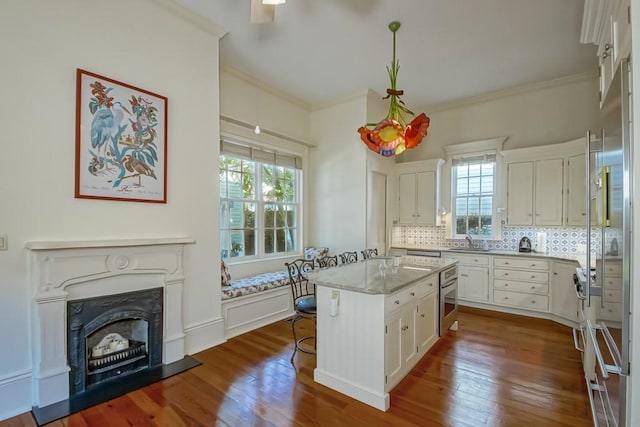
[0,0,223,419]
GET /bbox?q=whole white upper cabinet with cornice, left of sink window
[396,159,444,225]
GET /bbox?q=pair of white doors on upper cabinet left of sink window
[398,171,437,225]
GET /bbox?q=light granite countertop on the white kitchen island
[308,256,457,294]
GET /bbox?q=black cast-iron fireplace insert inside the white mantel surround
[67,288,163,396]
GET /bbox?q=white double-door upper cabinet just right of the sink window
[507,158,564,226]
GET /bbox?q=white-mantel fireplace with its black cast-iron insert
[26,238,194,408]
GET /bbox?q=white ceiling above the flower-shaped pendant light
[180,0,597,110]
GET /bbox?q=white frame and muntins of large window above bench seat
[218,151,303,263]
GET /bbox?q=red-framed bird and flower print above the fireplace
[75,68,168,203]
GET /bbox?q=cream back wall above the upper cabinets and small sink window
[398,76,599,162]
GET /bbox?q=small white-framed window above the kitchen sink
[452,155,496,238]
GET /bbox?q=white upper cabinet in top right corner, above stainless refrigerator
[580,0,631,105]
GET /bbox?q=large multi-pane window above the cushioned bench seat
[219,144,301,259]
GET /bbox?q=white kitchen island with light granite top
[309,257,457,411]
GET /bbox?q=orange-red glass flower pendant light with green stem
[358,21,430,157]
